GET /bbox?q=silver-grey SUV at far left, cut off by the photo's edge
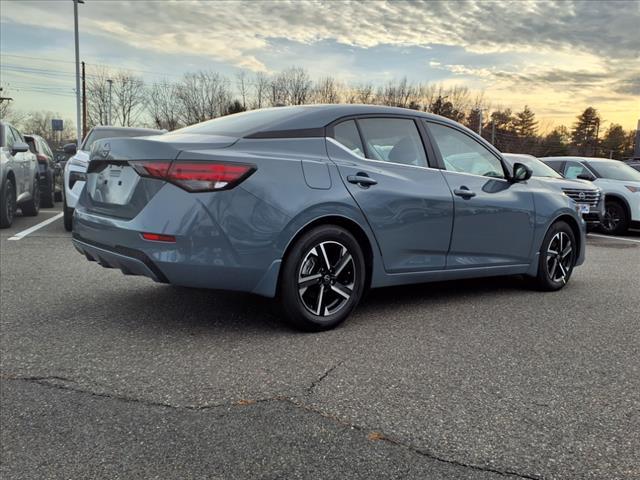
[0,122,40,228]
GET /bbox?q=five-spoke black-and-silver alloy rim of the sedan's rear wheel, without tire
[298,241,356,316]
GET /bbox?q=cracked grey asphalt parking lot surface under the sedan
[0,209,640,479]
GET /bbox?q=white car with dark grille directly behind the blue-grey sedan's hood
[503,153,604,228]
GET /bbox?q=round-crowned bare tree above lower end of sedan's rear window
[177,71,231,125]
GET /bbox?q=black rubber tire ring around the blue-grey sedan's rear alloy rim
[279,225,366,331]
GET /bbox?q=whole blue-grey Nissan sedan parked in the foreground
[73,105,585,330]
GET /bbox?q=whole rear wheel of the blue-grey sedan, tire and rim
[280,225,366,332]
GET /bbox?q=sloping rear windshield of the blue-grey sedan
[171,107,304,137]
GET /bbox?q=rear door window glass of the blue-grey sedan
[358,118,427,167]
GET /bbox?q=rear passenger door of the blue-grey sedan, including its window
[327,117,453,273]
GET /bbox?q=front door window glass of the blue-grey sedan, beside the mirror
[428,123,504,178]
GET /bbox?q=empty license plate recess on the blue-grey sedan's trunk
[86,163,140,205]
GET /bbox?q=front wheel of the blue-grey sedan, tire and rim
[535,221,578,292]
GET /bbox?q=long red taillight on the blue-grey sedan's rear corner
[131,161,256,192]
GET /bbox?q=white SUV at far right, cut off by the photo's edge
[541,157,640,235]
